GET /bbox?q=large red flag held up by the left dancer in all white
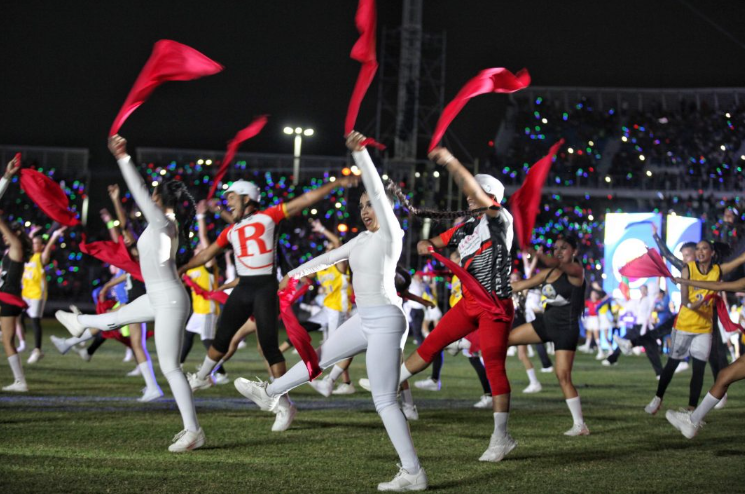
[109,39,223,136]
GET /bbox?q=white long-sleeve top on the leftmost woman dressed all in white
[117,155,179,285]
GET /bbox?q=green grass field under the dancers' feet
[0,321,745,494]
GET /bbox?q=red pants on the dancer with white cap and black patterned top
[417,295,515,396]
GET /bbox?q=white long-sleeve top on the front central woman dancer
[288,149,404,307]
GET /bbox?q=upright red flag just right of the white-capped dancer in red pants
[510,139,564,249]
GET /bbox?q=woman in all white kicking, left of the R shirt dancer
[56,135,204,453]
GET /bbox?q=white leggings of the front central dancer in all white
[267,305,419,473]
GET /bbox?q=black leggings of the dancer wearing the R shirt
[212,275,285,365]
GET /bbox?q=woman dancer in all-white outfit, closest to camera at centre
[235,132,427,491]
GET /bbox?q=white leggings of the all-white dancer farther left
[78,282,199,432]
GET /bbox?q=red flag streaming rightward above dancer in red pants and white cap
[429,67,530,152]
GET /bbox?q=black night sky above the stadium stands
[0,0,745,166]
